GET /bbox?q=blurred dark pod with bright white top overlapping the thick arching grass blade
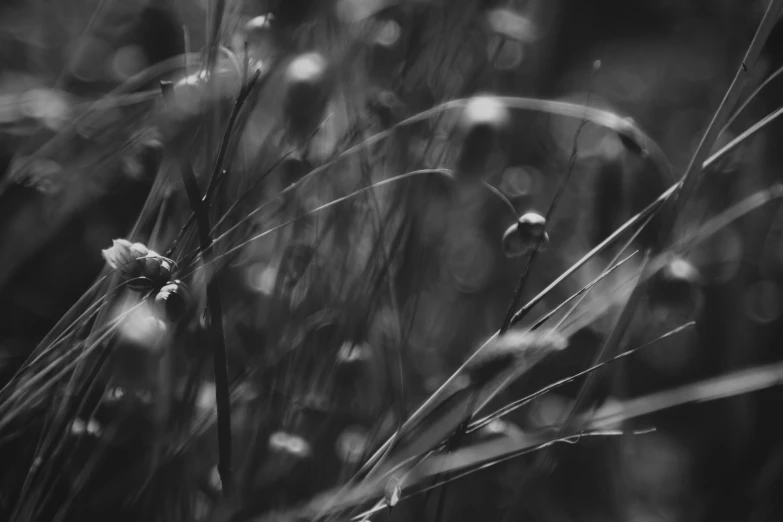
[455,96,511,183]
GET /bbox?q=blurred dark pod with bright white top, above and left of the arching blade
[283,53,329,146]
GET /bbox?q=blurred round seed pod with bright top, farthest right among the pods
[649,256,703,320]
